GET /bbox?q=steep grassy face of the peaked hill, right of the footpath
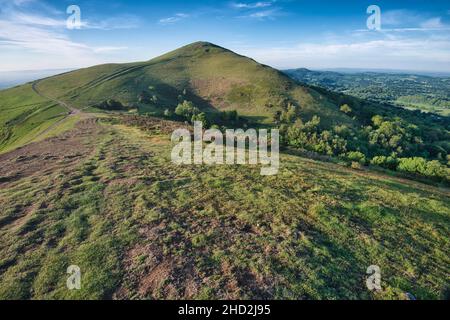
[34,42,351,123]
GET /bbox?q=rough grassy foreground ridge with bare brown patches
[0,116,450,299]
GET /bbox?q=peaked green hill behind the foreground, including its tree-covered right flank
[0,42,450,181]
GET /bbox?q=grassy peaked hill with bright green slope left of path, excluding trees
[0,42,352,152]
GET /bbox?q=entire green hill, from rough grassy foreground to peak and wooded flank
[0,43,450,299]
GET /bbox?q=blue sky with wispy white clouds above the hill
[0,0,450,72]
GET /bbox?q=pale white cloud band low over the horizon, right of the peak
[238,37,450,72]
